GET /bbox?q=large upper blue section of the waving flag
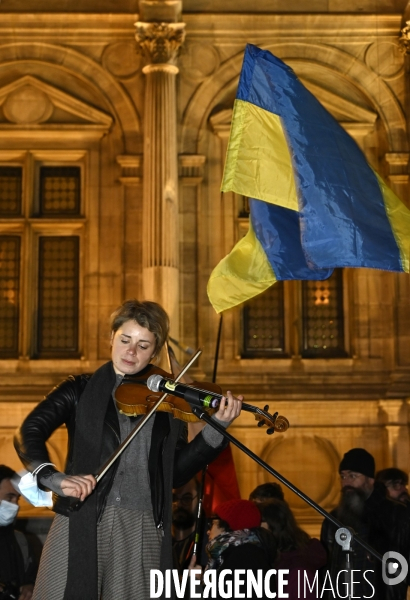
[237,45,403,272]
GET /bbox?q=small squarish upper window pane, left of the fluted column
[39,167,81,217]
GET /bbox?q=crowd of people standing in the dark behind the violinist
[0,448,410,600]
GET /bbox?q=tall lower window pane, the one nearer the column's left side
[37,236,79,358]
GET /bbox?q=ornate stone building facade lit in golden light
[0,0,410,531]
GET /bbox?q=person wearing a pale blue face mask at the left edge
[0,465,37,600]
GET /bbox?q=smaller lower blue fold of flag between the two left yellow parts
[249,199,333,281]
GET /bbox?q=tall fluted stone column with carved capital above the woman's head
[136,0,185,339]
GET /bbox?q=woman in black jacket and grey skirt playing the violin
[15,300,242,600]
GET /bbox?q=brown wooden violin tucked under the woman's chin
[115,364,289,435]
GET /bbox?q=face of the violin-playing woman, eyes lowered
[111,320,156,375]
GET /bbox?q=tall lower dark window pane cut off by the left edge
[0,236,20,358]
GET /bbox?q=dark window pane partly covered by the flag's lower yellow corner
[243,282,285,358]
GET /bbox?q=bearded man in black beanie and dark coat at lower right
[321,448,410,600]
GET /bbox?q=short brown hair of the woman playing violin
[110,300,169,356]
